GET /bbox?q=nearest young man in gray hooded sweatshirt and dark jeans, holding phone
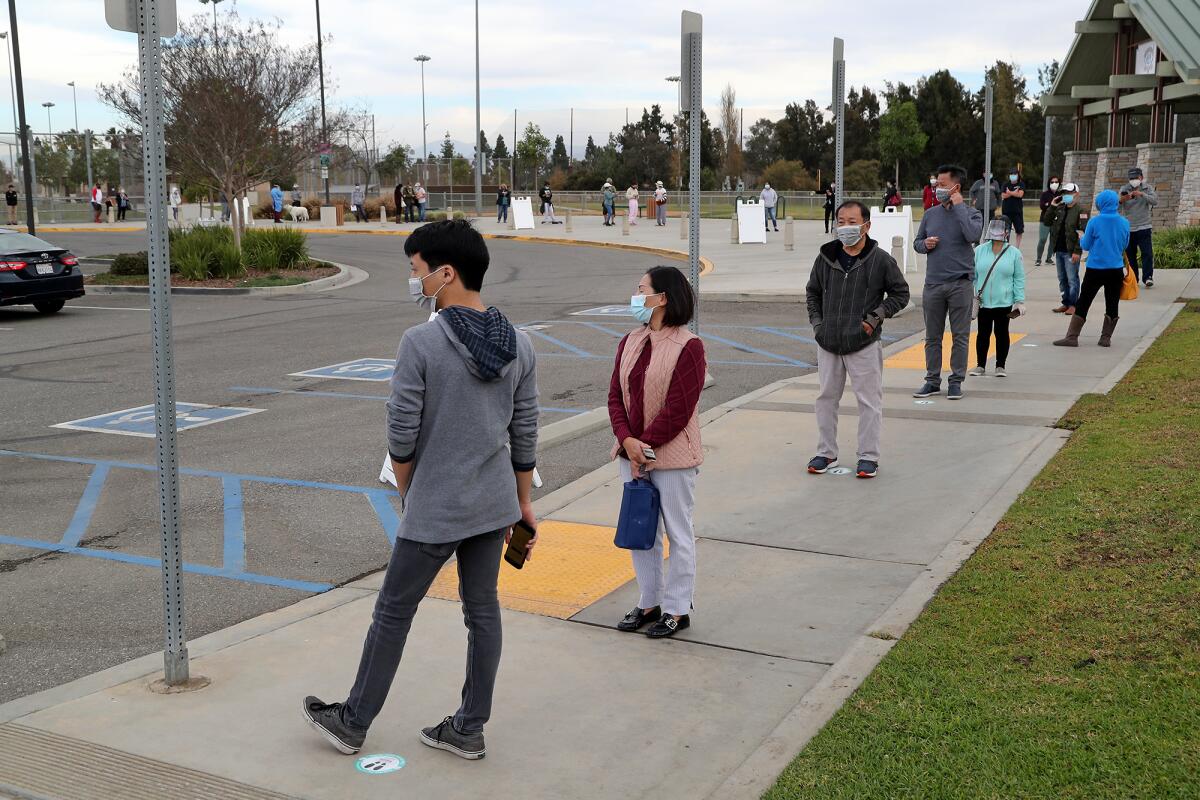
[304,219,538,759]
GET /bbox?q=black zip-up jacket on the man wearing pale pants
[805,237,908,355]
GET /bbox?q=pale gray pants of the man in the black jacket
[814,342,883,463]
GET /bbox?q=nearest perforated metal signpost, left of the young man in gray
[137,0,188,686]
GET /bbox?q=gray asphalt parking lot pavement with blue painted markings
[0,233,911,702]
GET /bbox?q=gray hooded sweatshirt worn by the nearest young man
[388,311,538,543]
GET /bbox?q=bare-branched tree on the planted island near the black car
[97,12,342,247]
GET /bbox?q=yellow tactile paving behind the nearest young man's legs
[430,519,667,619]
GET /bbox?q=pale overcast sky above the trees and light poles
[11,0,1088,155]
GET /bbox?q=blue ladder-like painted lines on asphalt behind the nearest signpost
[0,450,400,593]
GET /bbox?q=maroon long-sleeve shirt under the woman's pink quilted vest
[608,338,706,458]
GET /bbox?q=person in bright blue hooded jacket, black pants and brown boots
[1055,190,1129,347]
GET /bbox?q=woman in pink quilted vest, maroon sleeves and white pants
[608,266,707,638]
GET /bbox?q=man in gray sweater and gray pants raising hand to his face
[912,164,983,399]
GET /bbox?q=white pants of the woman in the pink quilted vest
[617,458,700,615]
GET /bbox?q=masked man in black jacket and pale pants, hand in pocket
[805,200,908,479]
